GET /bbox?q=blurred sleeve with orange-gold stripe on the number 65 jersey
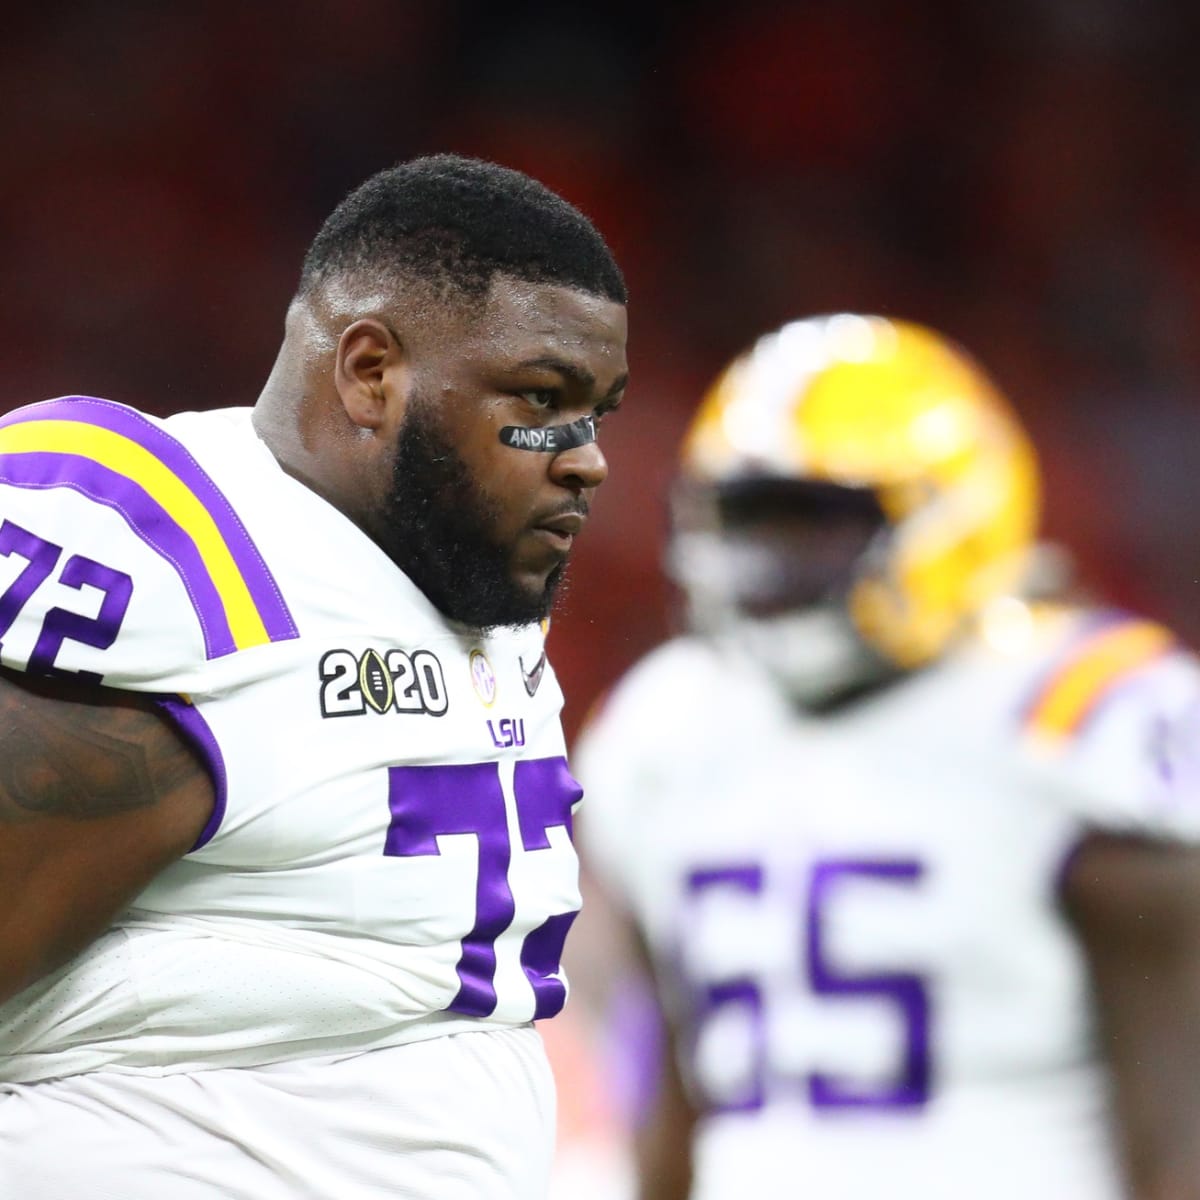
[1025,619,1200,842]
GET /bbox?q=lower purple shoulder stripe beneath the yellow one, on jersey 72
[0,451,238,659]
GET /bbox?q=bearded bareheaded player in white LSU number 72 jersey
[0,155,626,1200]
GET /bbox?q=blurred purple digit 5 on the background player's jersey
[806,859,932,1109]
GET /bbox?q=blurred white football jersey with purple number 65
[575,607,1200,1200]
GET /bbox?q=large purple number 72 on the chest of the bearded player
[383,757,583,1020]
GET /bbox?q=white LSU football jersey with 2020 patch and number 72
[0,397,581,1081]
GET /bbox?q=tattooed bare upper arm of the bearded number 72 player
[0,671,214,1001]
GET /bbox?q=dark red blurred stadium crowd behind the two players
[0,0,1200,733]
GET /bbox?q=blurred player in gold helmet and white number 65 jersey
[575,314,1200,1200]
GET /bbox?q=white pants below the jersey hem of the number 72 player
[0,1026,554,1200]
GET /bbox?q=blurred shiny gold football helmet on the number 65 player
[671,313,1039,686]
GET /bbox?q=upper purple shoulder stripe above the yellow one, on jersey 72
[0,396,299,642]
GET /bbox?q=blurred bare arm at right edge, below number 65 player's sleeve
[1063,835,1200,1200]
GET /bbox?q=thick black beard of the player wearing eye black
[377,396,565,629]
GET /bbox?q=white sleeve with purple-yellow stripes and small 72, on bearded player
[0,396,295,692]
